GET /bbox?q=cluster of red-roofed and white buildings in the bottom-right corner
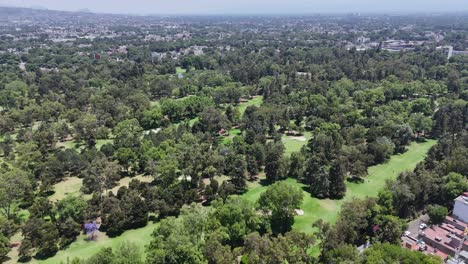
[402,193,468,264]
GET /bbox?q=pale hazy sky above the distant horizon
[0,0,468,14]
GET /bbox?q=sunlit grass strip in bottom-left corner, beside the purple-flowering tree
[36,222,158,264]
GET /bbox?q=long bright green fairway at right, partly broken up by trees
[242,140,436,233]
